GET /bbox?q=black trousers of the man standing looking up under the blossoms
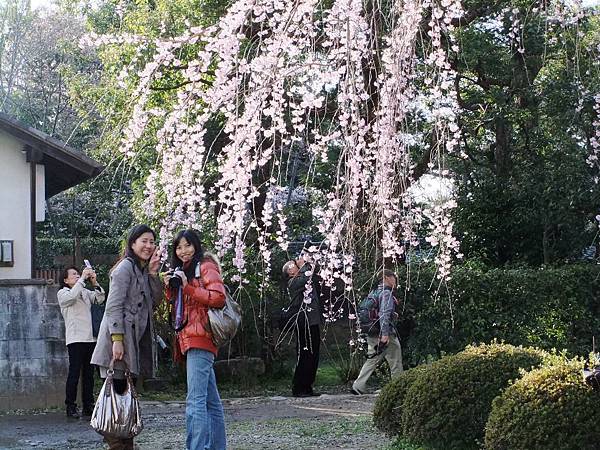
[292,320,321,395]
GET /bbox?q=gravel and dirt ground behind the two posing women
[0,394,389,450]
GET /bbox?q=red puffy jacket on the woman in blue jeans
[166,256,225,355]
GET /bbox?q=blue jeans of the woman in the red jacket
[185,348,226,450]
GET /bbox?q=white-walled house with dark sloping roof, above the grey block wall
[0,113,102,280]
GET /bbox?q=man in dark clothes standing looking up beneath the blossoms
[283,258,321,397]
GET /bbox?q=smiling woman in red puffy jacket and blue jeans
[164,230,226,450]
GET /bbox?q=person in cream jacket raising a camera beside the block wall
[57,267,104,419]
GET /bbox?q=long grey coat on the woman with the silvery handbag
[91,258,162,378]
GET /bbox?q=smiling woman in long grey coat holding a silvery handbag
[92,225,162,450]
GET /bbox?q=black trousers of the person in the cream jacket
[65,342,96,407]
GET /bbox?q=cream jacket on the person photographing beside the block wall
[57,278,105,345]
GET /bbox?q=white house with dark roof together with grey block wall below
[0,113,102,411]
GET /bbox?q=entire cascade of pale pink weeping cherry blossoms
[86,0,463,290]
